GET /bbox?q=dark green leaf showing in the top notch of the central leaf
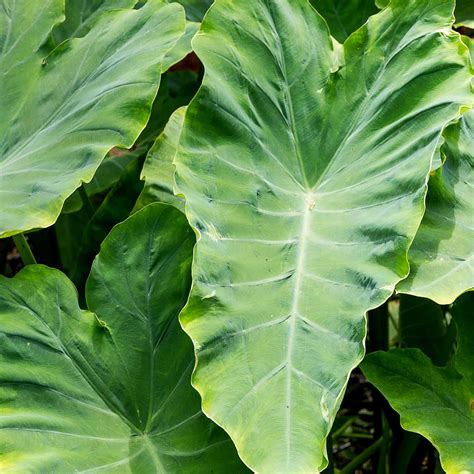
[310,0,378,43]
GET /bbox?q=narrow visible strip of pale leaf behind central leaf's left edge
[135,107,186,210]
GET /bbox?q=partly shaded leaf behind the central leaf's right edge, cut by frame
[397,110,474,304]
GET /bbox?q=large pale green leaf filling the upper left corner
[0,0,184,236]
